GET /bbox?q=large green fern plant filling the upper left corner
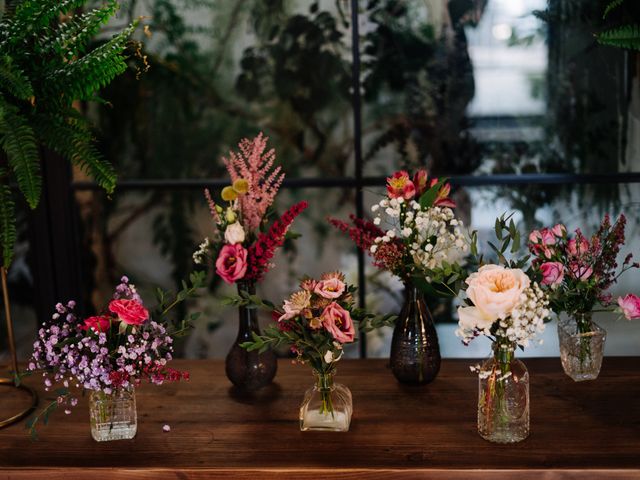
[0,0,138,268]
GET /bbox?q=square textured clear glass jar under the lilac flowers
[89,387,138,442]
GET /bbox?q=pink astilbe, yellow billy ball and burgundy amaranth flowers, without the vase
[193,133,307,284]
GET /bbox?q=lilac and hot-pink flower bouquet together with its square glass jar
[27,273,204,442]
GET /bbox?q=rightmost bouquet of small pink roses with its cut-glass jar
[529,215,640,381]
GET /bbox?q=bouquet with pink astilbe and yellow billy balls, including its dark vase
[193,134,307,390]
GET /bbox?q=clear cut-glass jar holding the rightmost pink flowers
[558,313,607,382]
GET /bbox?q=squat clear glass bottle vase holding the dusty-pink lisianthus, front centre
[300,370,353,432]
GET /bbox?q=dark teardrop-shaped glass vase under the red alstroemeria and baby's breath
[390,282,441,385]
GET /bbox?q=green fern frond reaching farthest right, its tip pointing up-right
[48,22,138,103]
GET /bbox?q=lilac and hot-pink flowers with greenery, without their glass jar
[27,274,204,435]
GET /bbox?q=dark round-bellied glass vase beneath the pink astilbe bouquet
[225,282,278,391]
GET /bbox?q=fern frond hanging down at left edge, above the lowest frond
[0,97,42,208]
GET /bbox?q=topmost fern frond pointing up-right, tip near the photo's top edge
[38,0,120,59]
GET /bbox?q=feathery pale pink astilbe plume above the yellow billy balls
[223,132,284,231]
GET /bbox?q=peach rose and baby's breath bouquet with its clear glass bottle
[456,218,550,443]
